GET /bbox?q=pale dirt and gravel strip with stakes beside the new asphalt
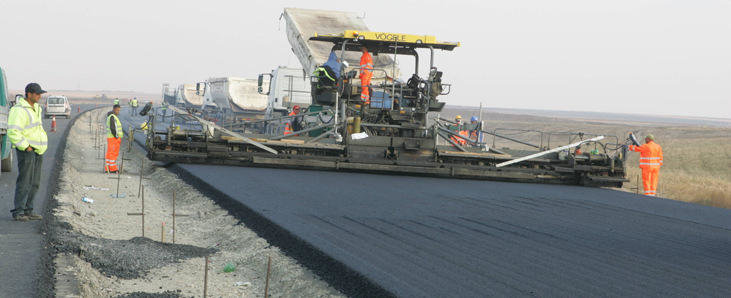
[52,110,342,297]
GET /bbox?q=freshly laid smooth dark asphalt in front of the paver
[126,112,731,297]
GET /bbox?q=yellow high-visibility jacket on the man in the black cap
[8,98,48,155]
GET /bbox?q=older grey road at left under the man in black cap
[0,105,96,297]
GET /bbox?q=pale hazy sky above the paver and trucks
[0,0,731,118]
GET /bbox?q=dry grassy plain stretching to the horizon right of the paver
[442,110,731,209]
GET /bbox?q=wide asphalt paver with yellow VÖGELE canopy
[146,22,627,187]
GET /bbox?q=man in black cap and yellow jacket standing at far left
[8,83,48,221]
